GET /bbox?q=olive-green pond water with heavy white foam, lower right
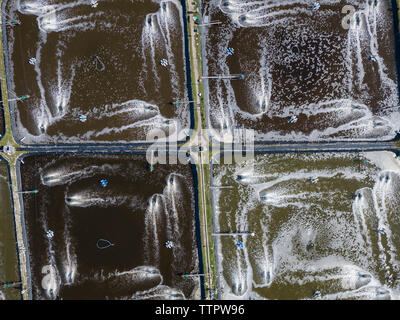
[213,152,400,300]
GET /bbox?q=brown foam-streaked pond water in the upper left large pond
[7,0,189,143]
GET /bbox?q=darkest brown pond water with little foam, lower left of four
[21,154,199,299]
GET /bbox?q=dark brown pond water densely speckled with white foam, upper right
[202,0,400,140]
